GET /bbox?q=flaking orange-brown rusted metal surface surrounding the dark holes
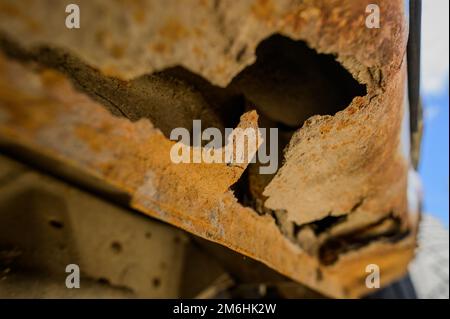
[0,0,416,297]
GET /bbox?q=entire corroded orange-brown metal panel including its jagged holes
[0,0,418,297]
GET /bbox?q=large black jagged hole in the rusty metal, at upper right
[231,35,367,129]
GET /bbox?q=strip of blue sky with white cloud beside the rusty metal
[419,0,449,228]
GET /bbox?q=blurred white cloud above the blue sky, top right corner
[421,0,450,94]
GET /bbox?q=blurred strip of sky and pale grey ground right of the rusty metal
[410,0,449,298]
